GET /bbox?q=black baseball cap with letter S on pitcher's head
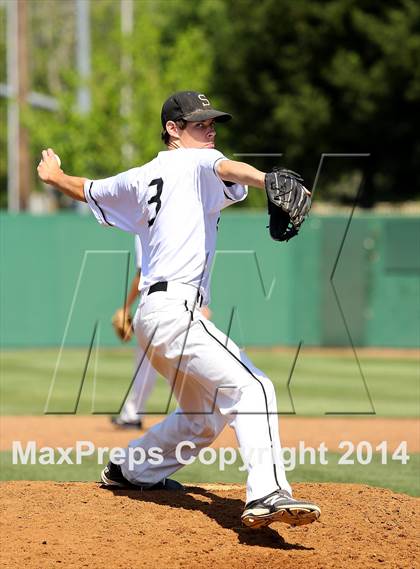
[161,91,232,128]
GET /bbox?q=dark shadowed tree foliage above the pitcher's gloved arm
[214,0,420,205]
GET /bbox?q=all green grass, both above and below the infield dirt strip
[0,347,420,495]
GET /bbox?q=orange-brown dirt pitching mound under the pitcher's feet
[0,481,419,569]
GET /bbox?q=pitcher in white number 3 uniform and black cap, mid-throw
[38,91,320,527]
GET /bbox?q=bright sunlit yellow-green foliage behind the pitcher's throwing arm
[8,0,212,200]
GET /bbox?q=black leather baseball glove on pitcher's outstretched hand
[265,168,311,241]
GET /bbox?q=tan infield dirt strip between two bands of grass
[0,415,420,452]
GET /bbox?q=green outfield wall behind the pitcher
[0,210,420,348]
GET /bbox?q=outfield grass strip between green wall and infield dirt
[0,348,420,417]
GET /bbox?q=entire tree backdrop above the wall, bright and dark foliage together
[0,0,420,205]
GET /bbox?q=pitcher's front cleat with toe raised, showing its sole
[241,490,321,529]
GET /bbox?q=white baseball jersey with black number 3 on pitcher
[84,148,247,304]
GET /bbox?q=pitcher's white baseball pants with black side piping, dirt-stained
[121,283,291,502]
